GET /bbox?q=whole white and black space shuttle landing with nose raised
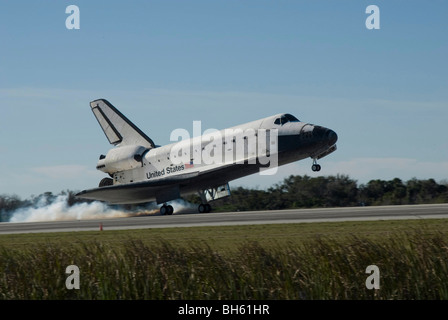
[76,99,338,215]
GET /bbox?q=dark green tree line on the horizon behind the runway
[0,175,448,221]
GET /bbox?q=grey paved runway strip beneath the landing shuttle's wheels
[0,204,448,234]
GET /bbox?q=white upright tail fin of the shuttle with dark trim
[90,99,155,149]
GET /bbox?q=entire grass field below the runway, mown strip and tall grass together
[0,219,448,299]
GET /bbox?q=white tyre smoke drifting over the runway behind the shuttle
[9,195,194,222]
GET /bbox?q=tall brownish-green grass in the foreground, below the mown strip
[0,231,448,299]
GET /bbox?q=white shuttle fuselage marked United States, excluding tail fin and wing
[97,115,336,185]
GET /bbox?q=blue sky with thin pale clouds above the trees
[0,0,448,198]
